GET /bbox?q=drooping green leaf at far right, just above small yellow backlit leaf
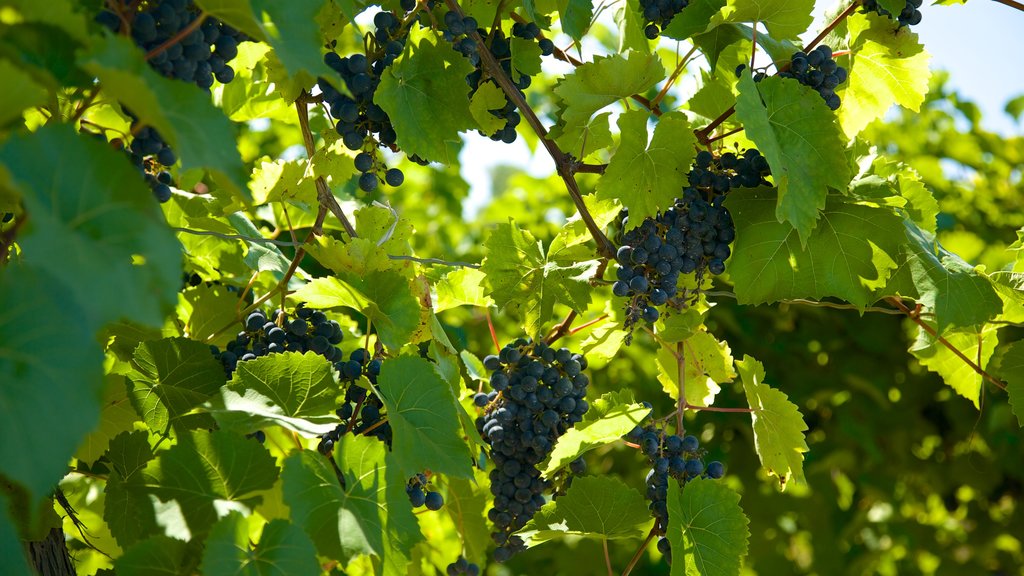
[882,221,1002,334]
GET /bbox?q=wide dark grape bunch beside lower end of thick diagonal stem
[611,149,770,327]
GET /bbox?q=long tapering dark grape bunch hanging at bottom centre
[476,338,590,562]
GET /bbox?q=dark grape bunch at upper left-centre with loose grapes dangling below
[317,11,426,193]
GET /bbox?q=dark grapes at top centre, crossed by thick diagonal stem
[443,11,555,143]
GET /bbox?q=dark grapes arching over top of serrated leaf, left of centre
[211,304,344,377]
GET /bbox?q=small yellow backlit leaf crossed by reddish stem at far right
[910,324,999,409]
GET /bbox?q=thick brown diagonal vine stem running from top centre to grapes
[444,0,615,258]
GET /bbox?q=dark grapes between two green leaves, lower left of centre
[316,342,391,455]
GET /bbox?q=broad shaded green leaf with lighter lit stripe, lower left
[146,430,281,534]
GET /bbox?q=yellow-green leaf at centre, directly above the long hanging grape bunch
[480,218,597,334]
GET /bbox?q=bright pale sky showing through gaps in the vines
[462,0,1024,218]
